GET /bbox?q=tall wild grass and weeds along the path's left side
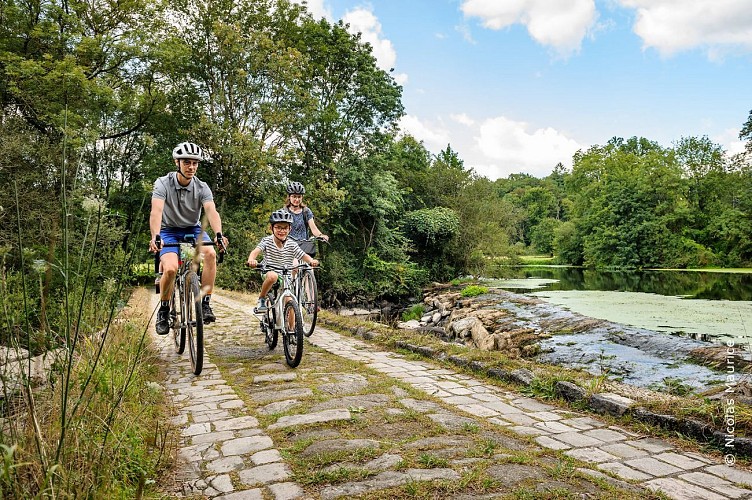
[0,288,176,498]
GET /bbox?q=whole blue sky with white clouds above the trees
[294,0,752,179]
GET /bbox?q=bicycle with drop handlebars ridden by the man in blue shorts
[154,234,224,375]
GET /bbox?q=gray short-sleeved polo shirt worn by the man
[151,172,214,228]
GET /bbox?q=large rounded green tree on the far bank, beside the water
[570,137,697,268]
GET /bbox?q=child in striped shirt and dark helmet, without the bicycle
[248,210,319,313]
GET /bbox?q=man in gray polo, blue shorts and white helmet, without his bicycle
[149,142,229,335]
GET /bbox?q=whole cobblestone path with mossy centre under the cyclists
[145,294,752,500]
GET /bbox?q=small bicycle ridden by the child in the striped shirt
[253,264,307,368]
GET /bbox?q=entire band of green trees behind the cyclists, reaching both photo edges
[0,0,752,340]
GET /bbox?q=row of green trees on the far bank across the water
[497,134,752,269]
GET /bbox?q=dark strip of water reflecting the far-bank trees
[493,266,752,301]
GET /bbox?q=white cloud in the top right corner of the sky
[619,0,752,59]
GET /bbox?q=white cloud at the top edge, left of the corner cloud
[460,0,597,56]
